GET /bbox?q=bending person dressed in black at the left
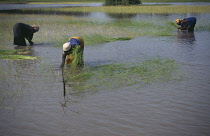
[13,23,39,46]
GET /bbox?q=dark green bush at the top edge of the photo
[105,0,141,6]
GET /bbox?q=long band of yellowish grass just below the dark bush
[36,5,210,14]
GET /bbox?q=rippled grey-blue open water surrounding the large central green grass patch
[0,2,210,136]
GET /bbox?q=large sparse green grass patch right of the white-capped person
[67,57,181,93]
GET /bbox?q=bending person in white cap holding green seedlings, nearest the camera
[61,37,84,67]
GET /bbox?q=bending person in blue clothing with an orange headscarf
[176,17,196,32]
